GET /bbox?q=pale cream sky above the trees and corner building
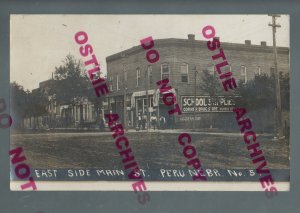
[10,15,290,90]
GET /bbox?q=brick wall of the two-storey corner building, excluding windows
[106,37,289,127]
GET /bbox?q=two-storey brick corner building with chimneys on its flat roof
[106,34,289,128]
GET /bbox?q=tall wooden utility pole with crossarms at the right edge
[269,14,283,138]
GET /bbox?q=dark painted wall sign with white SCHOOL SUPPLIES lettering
[181,95,240,113]
